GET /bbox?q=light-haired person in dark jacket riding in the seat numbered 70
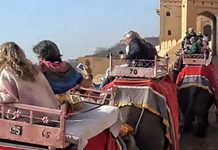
[99,31,158,88]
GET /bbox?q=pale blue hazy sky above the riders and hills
[0,0,159,60]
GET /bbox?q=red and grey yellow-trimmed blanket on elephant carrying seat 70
[104,78,179,150]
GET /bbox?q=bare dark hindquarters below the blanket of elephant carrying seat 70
[120,106,169,150]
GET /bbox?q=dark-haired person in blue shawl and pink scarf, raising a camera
[33,40,93,94]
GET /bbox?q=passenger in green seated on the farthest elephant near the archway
[186,37,201,54]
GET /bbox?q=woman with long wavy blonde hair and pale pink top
[0,42,59,108]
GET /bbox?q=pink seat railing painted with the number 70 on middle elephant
[109,55,168,78]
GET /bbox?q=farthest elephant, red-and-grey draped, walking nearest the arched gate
[176,64,217,137]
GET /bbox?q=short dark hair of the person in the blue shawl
[33,40,62,59]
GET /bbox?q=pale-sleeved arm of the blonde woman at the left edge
[0,70,19,103]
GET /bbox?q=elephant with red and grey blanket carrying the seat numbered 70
[106,79,179,150]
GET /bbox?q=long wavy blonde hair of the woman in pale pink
[0,42,39,81]
